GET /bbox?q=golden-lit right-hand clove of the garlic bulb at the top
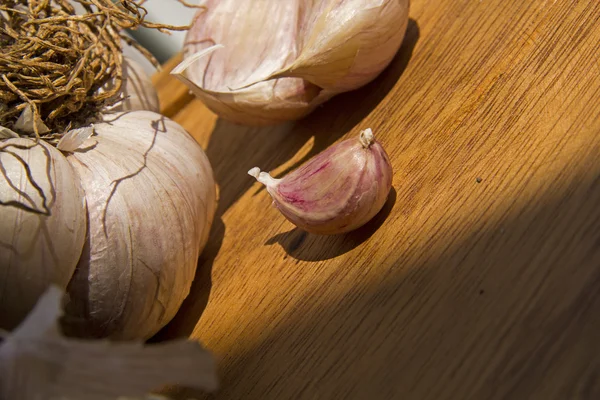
[272,0,409,92]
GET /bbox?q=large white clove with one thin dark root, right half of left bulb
[67,111,216,339]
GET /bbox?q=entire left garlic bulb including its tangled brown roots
[0,0,216,339]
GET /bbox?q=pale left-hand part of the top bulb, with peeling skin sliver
[176,0,328,125]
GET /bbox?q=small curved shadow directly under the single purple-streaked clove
[265,188,396,261]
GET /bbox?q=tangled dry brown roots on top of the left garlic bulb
[0,0,202,137]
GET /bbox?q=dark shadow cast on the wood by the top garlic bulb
[206,19,420,216]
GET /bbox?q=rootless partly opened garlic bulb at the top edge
[174,0,409,125]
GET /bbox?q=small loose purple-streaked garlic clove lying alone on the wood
[248,129,393,235]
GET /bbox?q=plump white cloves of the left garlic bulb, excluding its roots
[0,111,216,340]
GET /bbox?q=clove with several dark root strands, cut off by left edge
[0,138,86,329]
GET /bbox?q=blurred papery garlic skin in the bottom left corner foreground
[0,286,219,400]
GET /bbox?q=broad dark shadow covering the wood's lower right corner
[168,156,600,400]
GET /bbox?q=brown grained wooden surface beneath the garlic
[155,0,600,400]
